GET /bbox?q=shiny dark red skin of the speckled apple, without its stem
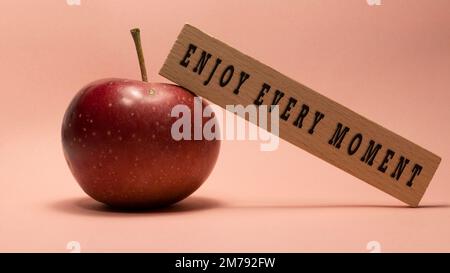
[61,79,220,208]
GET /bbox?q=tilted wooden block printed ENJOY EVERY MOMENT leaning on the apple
[159,25,441,207]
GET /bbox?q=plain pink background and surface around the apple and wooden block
[0,0,450,252]
